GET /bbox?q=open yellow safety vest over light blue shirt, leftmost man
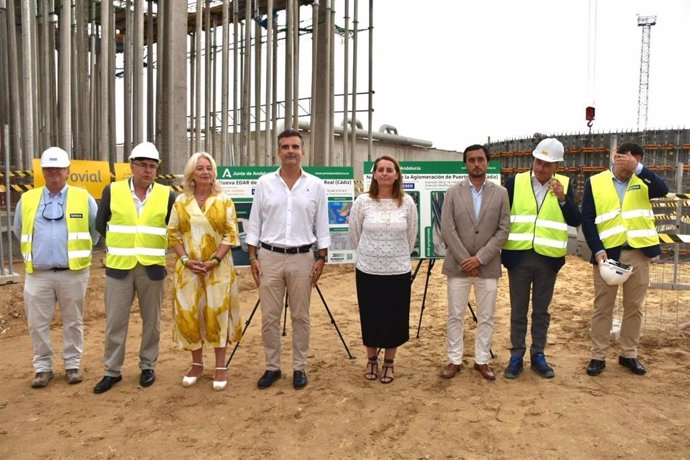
[21,186,92,273]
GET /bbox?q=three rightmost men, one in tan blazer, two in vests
[441,138,668,380]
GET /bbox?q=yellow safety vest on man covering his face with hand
[590,171,659,249]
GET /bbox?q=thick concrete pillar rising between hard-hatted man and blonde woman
[160,0,189,174]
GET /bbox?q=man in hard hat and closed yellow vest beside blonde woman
[93,142,175,393]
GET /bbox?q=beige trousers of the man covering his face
[591,249,650,361]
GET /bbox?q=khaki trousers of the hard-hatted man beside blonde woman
[103,264,165,377]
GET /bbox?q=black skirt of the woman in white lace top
[355,270,412,348]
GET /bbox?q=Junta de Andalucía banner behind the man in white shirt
[218,166,355,267]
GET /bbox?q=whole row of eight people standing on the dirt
[14,130,668,394]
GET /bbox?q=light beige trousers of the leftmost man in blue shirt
[24,268,89,372]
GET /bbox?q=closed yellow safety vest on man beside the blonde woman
[105,180,170,270]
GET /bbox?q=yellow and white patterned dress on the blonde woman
[168,193,242,350]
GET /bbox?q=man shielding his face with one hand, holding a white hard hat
[582,143,668,376]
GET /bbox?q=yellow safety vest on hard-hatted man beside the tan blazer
[503,171,570,257]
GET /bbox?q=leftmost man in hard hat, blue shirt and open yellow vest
[14,147,98,388]
